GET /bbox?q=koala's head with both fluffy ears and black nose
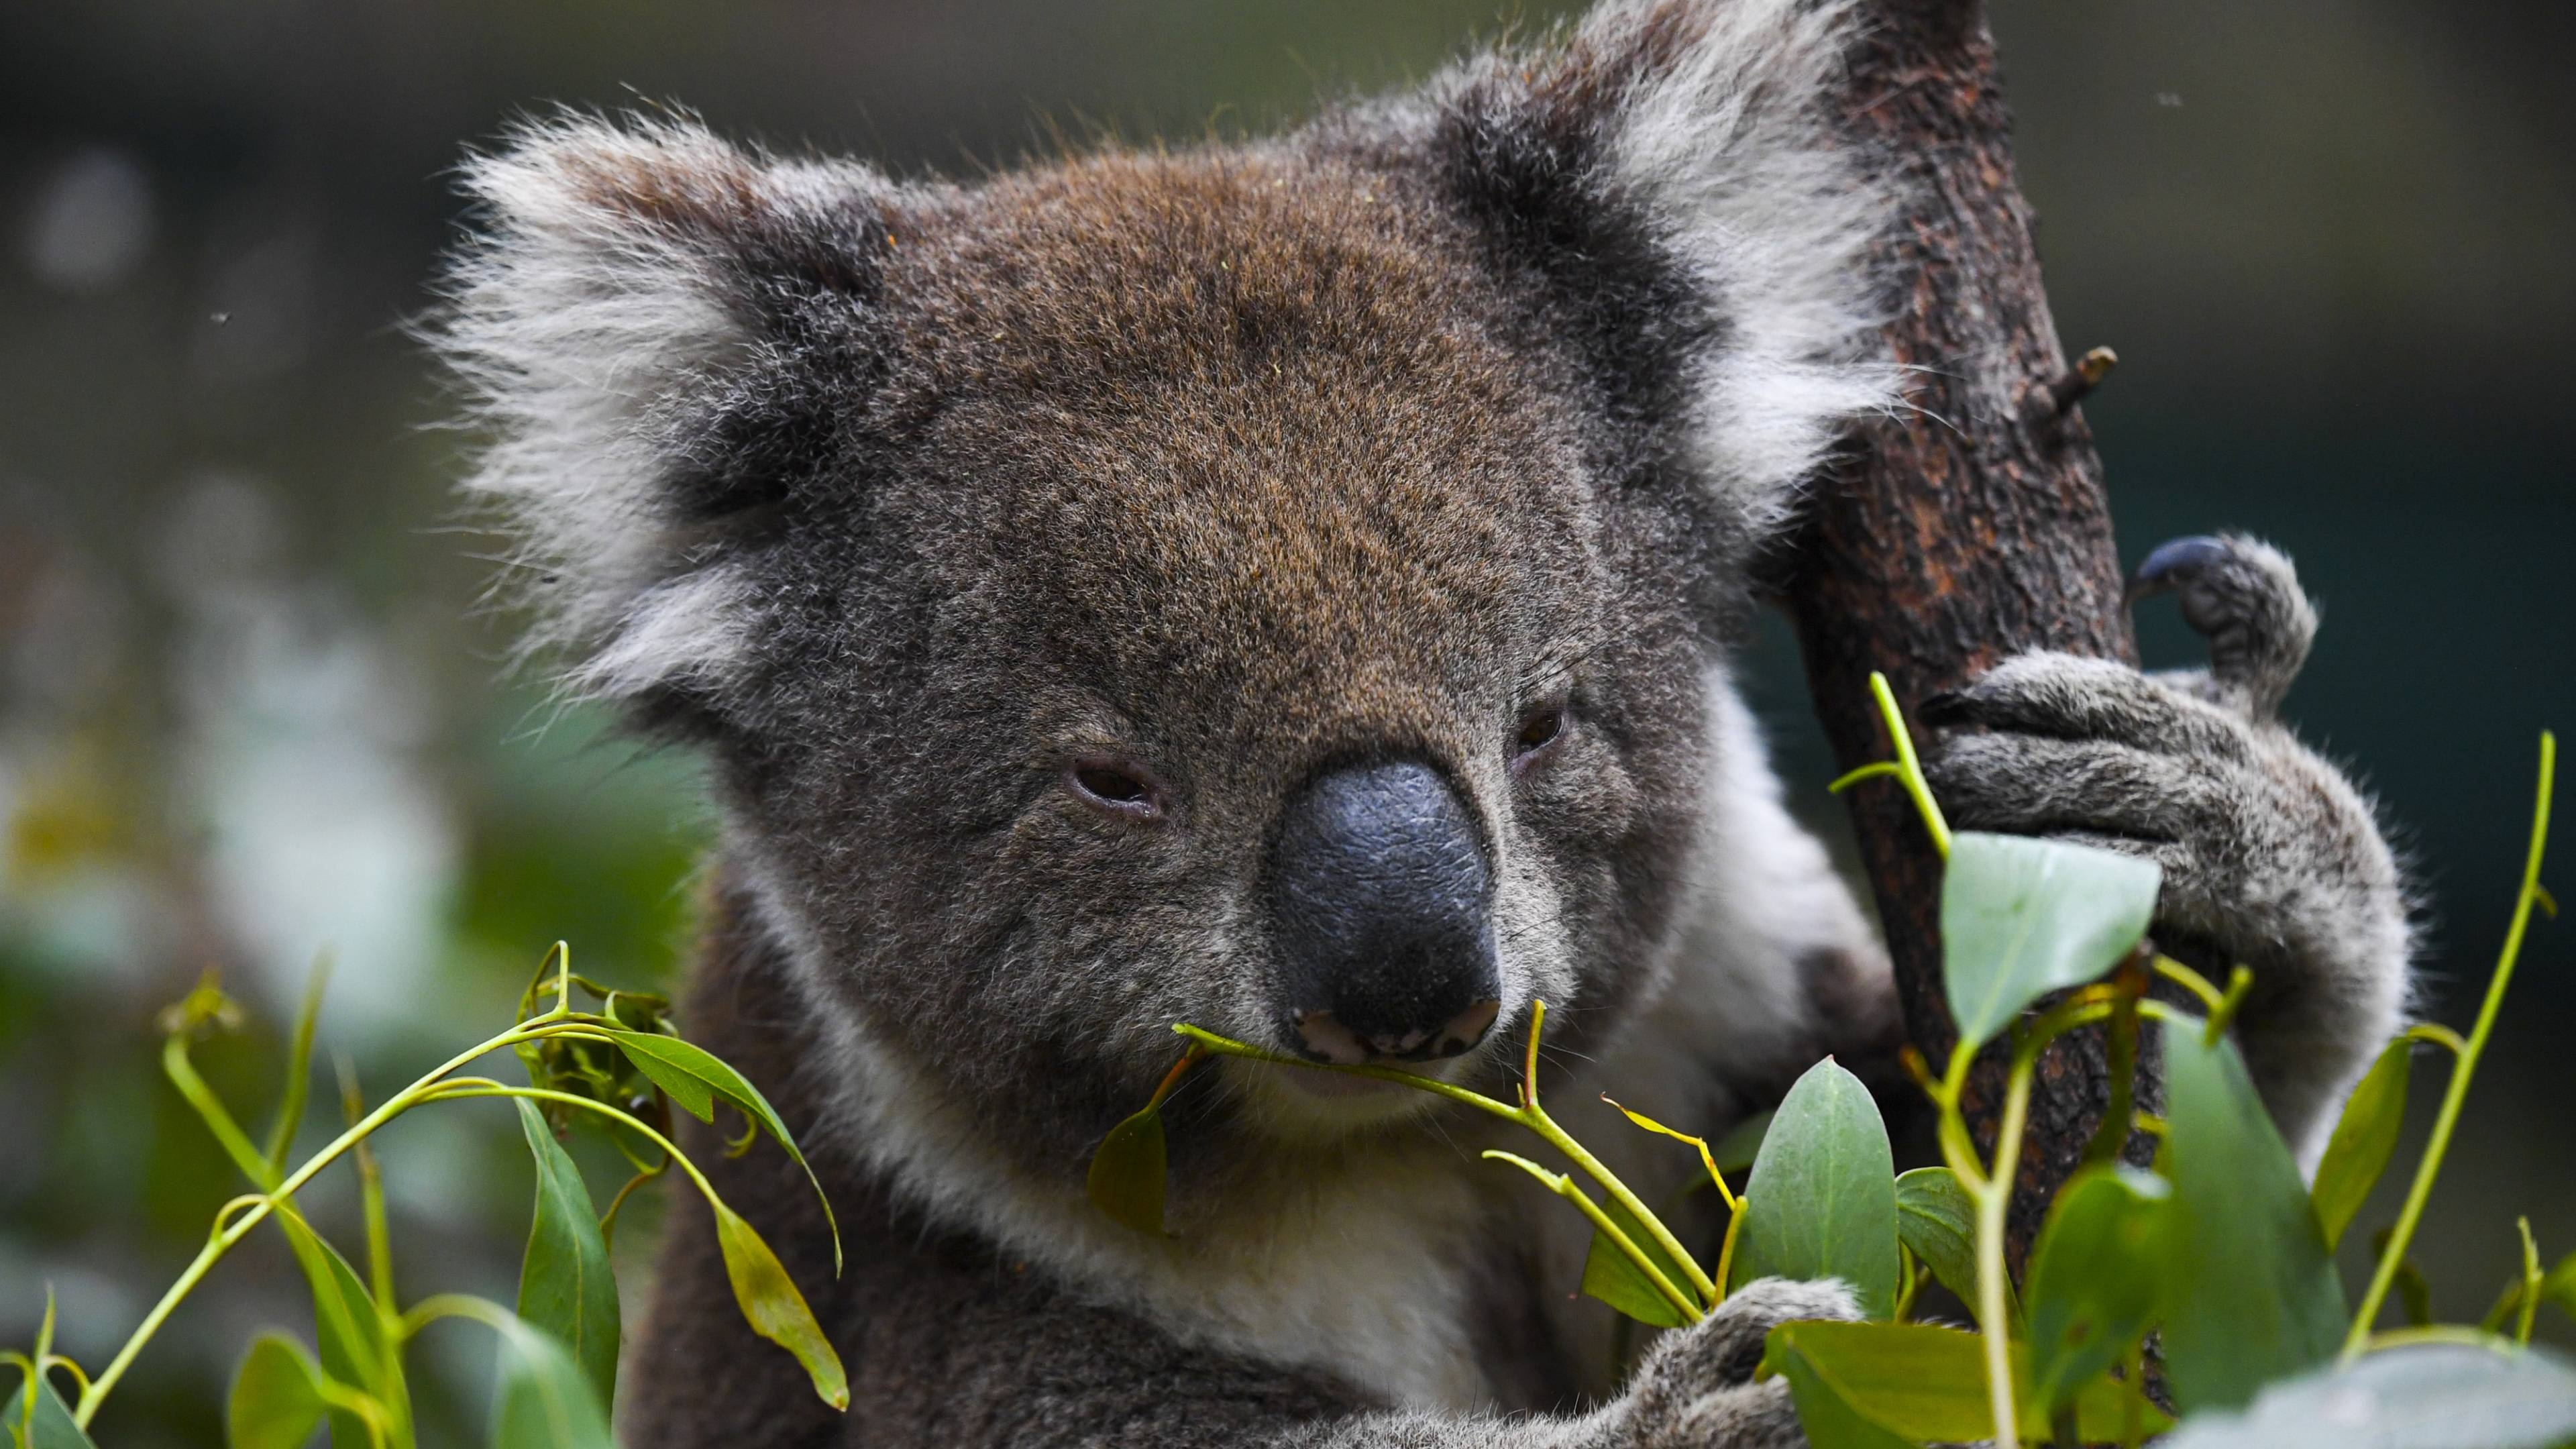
[441,0,1886,1171]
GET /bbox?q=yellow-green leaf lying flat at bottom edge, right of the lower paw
[1762,1323,2171,1449]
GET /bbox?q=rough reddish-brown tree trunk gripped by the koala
[1788,0,2153,1263]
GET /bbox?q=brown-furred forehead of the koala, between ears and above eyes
[860,152,1592,701]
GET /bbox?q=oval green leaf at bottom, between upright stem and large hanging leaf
[2025,1168,2174,1424]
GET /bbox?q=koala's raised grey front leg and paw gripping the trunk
[1922,536,2408,1161]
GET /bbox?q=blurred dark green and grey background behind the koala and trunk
[0,0,2576,1446]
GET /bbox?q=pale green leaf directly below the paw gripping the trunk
[1940,830,2164,1044]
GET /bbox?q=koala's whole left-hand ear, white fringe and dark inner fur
[430,116,889,701]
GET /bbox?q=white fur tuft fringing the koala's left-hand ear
[433,116,763,696]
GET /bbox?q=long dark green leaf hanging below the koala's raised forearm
[2164,1026,2347,1410]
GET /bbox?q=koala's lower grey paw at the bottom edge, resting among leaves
[1618,1279,1860,1449]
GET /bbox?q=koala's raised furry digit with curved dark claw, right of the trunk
[2128,534,2316,719]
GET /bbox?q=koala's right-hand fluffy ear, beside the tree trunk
[1430,0,1896,534]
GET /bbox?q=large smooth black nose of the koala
[1270,761,1502,1062]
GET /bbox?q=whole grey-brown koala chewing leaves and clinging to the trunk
[435,0,2408,1449]
